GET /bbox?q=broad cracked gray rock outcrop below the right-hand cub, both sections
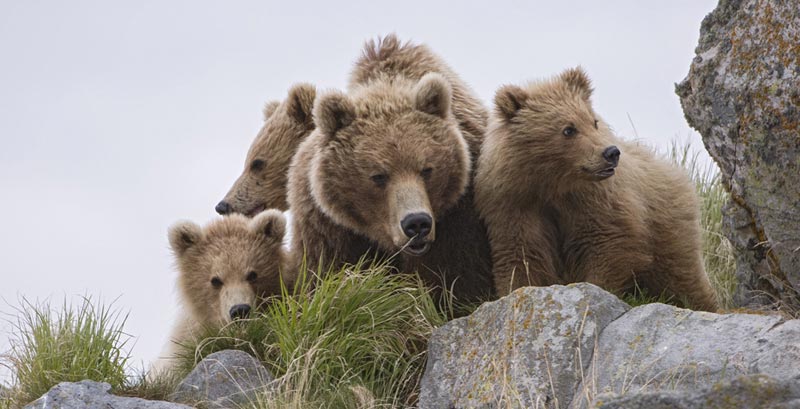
[419,283,800,409]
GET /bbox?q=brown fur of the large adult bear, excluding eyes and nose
[289,36,491,299]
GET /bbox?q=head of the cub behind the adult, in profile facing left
[215,84,316,217]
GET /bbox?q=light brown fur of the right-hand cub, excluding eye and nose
[476,68,717,310]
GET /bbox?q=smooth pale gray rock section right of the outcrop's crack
[573,304,800,407]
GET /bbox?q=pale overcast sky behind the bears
[0,0,716,380]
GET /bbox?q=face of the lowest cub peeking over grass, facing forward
[169,209,290,327]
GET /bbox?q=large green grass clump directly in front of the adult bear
[175,262,447,408]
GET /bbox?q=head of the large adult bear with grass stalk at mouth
[309,73,470,256]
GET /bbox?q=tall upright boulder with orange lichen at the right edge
[676,0,800,306]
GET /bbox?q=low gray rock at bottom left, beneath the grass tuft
[24,380,191,409]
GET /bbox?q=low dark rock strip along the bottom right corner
[597,375,800,409]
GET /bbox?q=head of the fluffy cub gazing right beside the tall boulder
[490,68,620,196]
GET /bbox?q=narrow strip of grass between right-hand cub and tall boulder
[668,141,737,309]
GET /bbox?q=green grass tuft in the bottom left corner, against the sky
[5,296,129,404]
